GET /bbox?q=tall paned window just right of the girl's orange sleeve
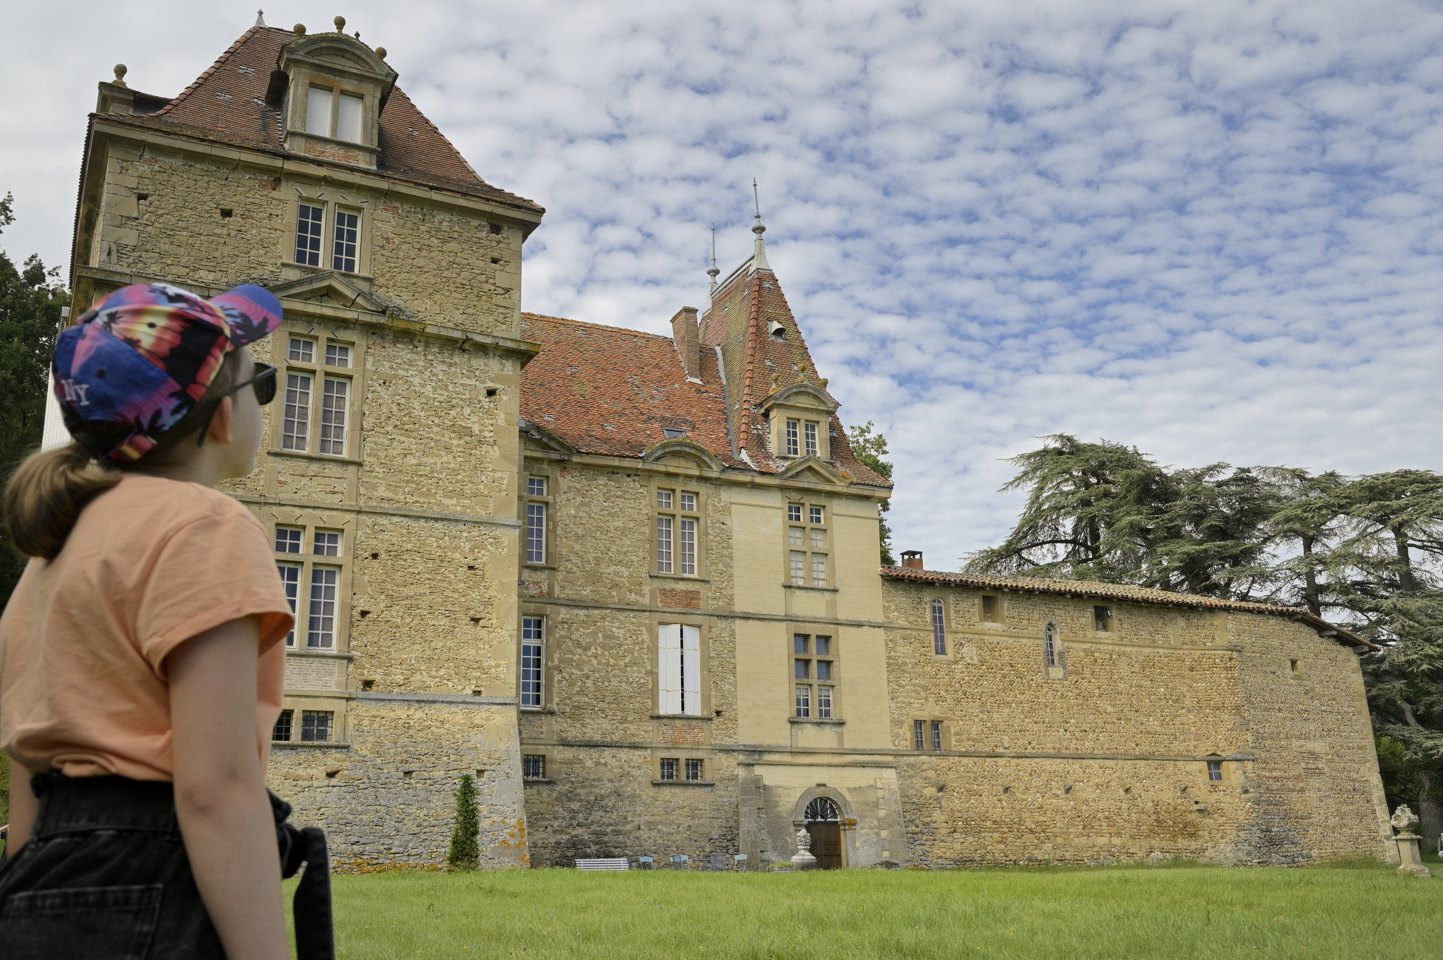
[273,524,346,651]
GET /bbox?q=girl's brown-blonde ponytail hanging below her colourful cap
[4,440,120,560]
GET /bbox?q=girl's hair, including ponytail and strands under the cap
[4,351,240,560]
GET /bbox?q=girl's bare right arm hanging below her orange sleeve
[166,616,290,960]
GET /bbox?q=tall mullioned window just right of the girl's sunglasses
[280,335,352,456]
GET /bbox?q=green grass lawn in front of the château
[301,863,1443,960]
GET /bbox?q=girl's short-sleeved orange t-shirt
[0,474,293,781]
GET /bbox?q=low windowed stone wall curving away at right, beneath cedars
[885,582,1388,866]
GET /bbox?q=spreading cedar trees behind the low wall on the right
[967,435,1443,834]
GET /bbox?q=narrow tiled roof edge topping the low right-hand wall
[882,567,1380,650]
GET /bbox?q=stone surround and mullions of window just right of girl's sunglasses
[267,318,365,463]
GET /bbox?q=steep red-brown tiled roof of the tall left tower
[105,26,543,212]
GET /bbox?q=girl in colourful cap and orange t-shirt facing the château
[0,284,330,960]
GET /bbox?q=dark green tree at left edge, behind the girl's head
[0,193,69,598]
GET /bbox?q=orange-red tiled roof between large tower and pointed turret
[521,313,746,469]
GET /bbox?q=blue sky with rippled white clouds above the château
[0,0,1443,570]
